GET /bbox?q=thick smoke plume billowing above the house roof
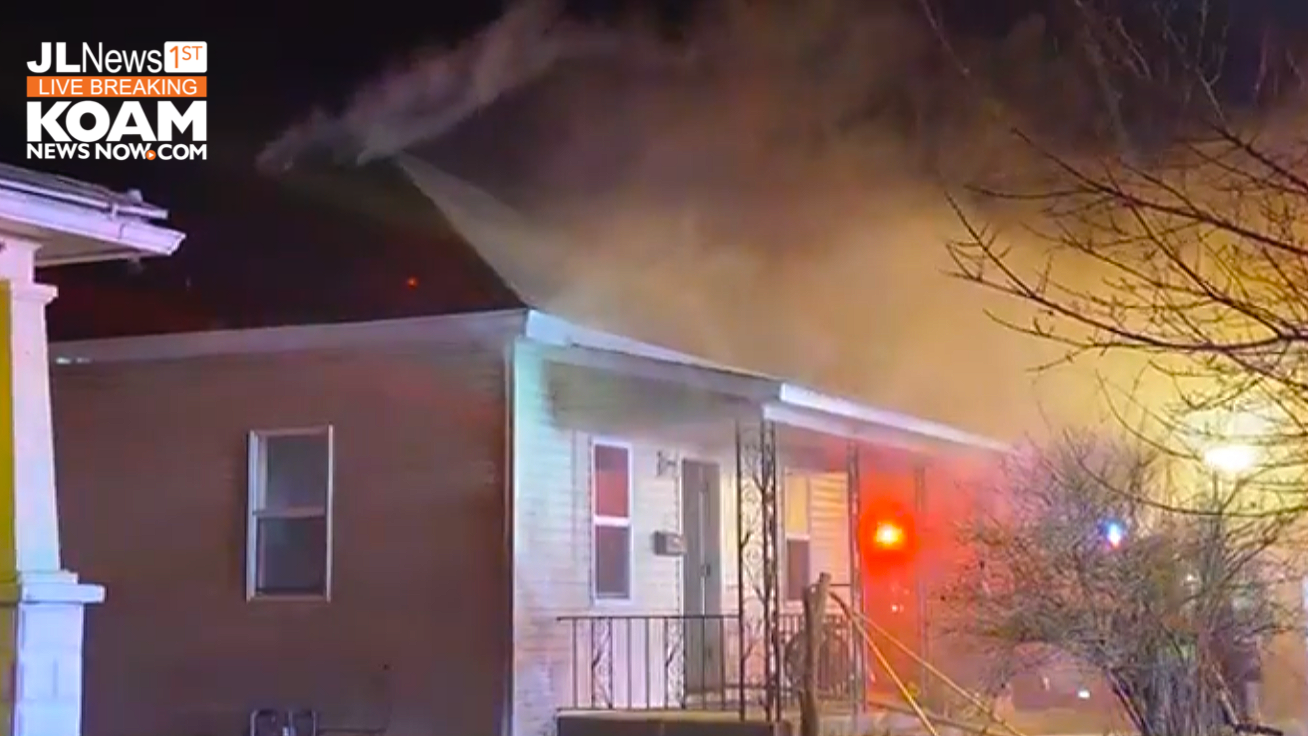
[260,0,1302,439]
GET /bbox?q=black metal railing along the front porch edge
[559,613,863,718]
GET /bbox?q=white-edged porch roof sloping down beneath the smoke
[523,310,1011,452]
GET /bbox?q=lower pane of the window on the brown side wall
[256,516,327,595]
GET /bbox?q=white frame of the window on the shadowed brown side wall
[246,425,336,601]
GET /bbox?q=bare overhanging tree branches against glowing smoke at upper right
[922,0,1308,501]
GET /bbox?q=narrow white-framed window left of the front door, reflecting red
[590,443,632,600]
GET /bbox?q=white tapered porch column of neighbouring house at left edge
[0,239,105,736]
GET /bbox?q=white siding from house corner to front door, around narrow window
[513,341,681,736]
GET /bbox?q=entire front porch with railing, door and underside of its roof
[519,320,1002,733]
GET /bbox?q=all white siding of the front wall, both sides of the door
[513,341,868,736]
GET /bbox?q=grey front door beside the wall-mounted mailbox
[681,460,727,697]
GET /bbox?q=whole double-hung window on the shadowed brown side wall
[246,427,332,599]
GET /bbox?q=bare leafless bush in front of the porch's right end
[944,435,1298,736]
